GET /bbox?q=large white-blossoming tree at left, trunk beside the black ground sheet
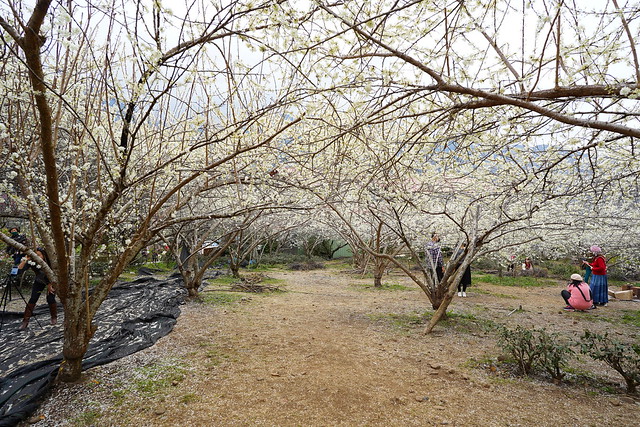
[0,0,310,381]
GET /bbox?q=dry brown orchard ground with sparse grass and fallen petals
[22,269,640,426]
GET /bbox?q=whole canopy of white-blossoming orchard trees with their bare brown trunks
[0,0,640,380]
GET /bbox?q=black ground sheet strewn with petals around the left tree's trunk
[0,277,186,426]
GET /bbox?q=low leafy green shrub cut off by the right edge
[580,331,640,393]
